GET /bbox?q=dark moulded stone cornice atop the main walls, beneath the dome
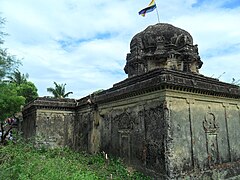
[95,69,240,103]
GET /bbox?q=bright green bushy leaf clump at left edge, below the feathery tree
[0,83,25,121]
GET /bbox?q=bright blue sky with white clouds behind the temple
[0,0,240,99]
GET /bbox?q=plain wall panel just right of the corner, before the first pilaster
[167,98,194,173]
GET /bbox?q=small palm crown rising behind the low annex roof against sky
[47,82,73,98]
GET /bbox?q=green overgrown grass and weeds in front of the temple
[0,143,150,180]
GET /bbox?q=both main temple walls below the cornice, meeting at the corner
[72,89,240,179]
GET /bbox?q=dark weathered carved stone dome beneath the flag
[124,23,203,77]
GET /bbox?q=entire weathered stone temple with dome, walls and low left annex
[22,23,240,179]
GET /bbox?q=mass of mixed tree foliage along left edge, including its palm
[0,17,38,121]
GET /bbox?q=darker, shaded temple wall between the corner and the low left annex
[75,91,168,174]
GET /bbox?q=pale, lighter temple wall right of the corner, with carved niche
[166,91,240,179]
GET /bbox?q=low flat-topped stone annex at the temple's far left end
[22,98,75,147]
